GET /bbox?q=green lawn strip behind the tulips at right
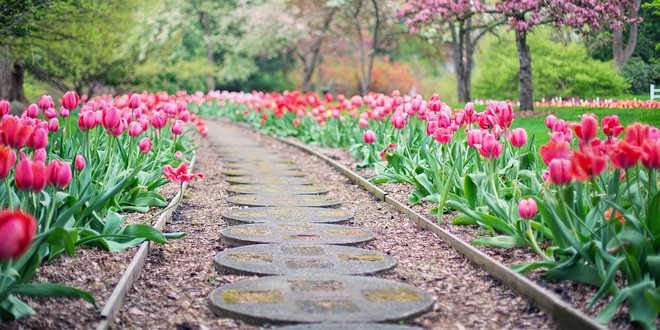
[512,107,660,147]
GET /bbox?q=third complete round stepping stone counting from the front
[220,222,376,246]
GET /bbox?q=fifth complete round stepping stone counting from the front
[227,194,341,207]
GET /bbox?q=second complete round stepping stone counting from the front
[215,244,396,275]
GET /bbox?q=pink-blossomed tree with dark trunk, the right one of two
[492,0,635,110]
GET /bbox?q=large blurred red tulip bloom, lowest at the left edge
[0,210,37,261]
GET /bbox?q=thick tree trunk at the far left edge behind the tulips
[0,46,28,103]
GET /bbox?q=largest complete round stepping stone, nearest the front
[209,272,433,323]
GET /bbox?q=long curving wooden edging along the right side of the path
[264,134,607,329]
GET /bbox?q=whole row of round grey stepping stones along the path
[209,127,434,330]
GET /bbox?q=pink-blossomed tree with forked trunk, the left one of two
[399,0,502,102]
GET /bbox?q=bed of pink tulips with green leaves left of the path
[0,92,206,319]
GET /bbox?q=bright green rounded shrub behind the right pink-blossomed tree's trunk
[473,29,628,100]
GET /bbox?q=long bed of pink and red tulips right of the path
[199,92,660,328]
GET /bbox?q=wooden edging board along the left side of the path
[96,155,196,330]
